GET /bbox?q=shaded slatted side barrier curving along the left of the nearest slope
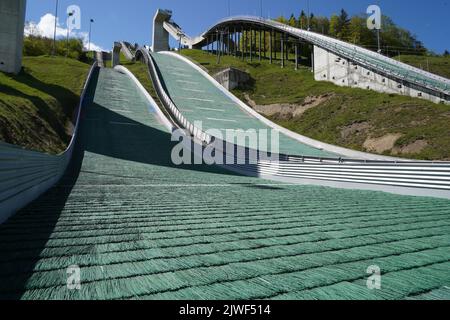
[0,62,98,223]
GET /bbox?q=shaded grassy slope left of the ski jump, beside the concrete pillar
[0,56,90,154]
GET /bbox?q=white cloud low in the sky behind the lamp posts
[24,13,107,51]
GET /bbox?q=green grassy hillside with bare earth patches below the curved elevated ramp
[182,50,450,160]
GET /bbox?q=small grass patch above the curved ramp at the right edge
[394,55,450,78]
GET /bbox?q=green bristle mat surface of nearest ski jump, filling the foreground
[0,69,450,299]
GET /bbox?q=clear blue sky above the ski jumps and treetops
[26,0,450,53]
